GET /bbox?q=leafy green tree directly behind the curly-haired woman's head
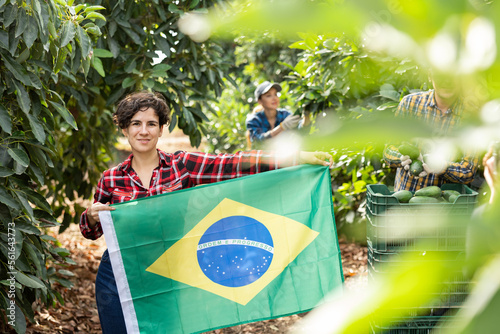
[49,0,242,229]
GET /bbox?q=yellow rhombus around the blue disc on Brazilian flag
[147,198,318,305]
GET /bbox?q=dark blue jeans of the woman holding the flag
[95,249,127,334]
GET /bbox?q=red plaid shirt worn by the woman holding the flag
[80,150,297,240]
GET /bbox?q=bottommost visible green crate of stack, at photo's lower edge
[370,316,455,334]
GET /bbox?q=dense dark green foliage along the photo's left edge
[0,0,103,333]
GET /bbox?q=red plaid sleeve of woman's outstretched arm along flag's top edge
[182,151,298,184]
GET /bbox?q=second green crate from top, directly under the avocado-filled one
[366,207,468,252]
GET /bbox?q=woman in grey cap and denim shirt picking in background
[246,81,310,146]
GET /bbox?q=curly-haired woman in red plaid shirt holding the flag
[80,92,332,334]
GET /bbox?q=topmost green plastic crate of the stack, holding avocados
[366,183,478,216]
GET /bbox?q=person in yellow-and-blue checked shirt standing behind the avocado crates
[384,75,479,191]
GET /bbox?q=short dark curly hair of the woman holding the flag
[113,91,170,129]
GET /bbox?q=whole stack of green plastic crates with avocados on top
[366,184,478,334]
